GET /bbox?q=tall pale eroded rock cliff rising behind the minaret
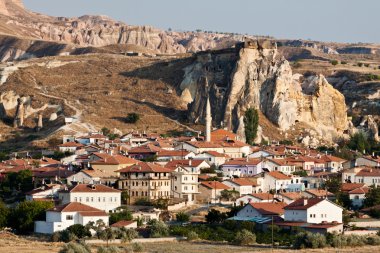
[181,41,347,141]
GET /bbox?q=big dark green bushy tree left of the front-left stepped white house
[10,201,54,233]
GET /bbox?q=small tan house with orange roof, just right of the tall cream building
[199,181,231,203]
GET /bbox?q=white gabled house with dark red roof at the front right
[284,198,343,224]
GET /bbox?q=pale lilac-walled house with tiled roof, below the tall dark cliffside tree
[221,158,263,178]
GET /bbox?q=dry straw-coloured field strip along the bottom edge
[0,235,380,253]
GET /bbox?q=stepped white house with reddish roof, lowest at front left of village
[34,202,109,234]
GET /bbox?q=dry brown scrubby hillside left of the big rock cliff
[0,54,192,149]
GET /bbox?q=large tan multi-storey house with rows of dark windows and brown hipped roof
[117,162,172,204]
